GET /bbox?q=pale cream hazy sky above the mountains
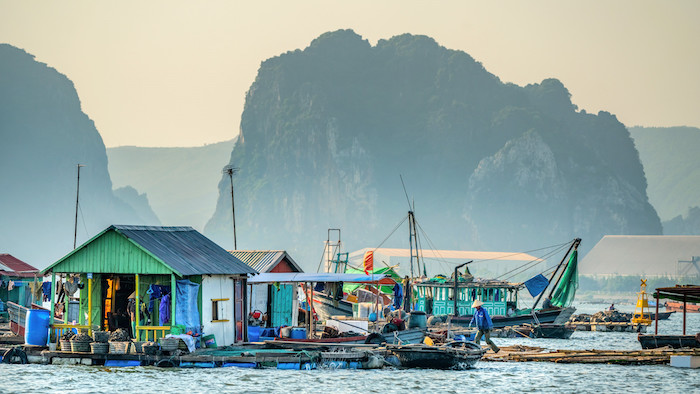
[0,0,700,147]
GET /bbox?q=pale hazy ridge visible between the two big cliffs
[107,138,236,230]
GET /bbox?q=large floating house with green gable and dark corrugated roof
[43,225,257,345]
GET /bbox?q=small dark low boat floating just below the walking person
[386,342,486,369]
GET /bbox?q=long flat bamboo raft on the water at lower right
[482,345,700,365]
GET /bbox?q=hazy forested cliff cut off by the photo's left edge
[0,44,156,268]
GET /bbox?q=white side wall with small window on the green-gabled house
[202,275,235,346]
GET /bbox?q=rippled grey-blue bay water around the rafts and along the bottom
[0,304,700,393]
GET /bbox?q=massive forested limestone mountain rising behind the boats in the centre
[205,30,661,270]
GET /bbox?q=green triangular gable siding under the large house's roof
[52,230,172,275]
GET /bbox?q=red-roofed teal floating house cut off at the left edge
[0,253,41,312]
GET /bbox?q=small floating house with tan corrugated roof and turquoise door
[230,250,304,327]
